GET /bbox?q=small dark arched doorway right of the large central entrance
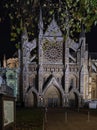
[68,92,78,108]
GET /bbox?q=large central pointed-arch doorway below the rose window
[44,85,62,107]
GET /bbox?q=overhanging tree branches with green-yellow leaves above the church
[1,0,97,41]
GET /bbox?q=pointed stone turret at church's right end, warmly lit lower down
[79,26,89,99]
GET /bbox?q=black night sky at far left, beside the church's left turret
[0,20,17,61]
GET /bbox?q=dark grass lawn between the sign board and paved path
[16,108,44,130]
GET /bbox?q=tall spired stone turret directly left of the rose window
[38,7,43,106]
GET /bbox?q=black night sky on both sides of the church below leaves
[0,17,97,64]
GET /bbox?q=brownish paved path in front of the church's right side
[45,109,97,130]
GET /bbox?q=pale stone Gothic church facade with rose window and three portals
[22,8,97,107]
